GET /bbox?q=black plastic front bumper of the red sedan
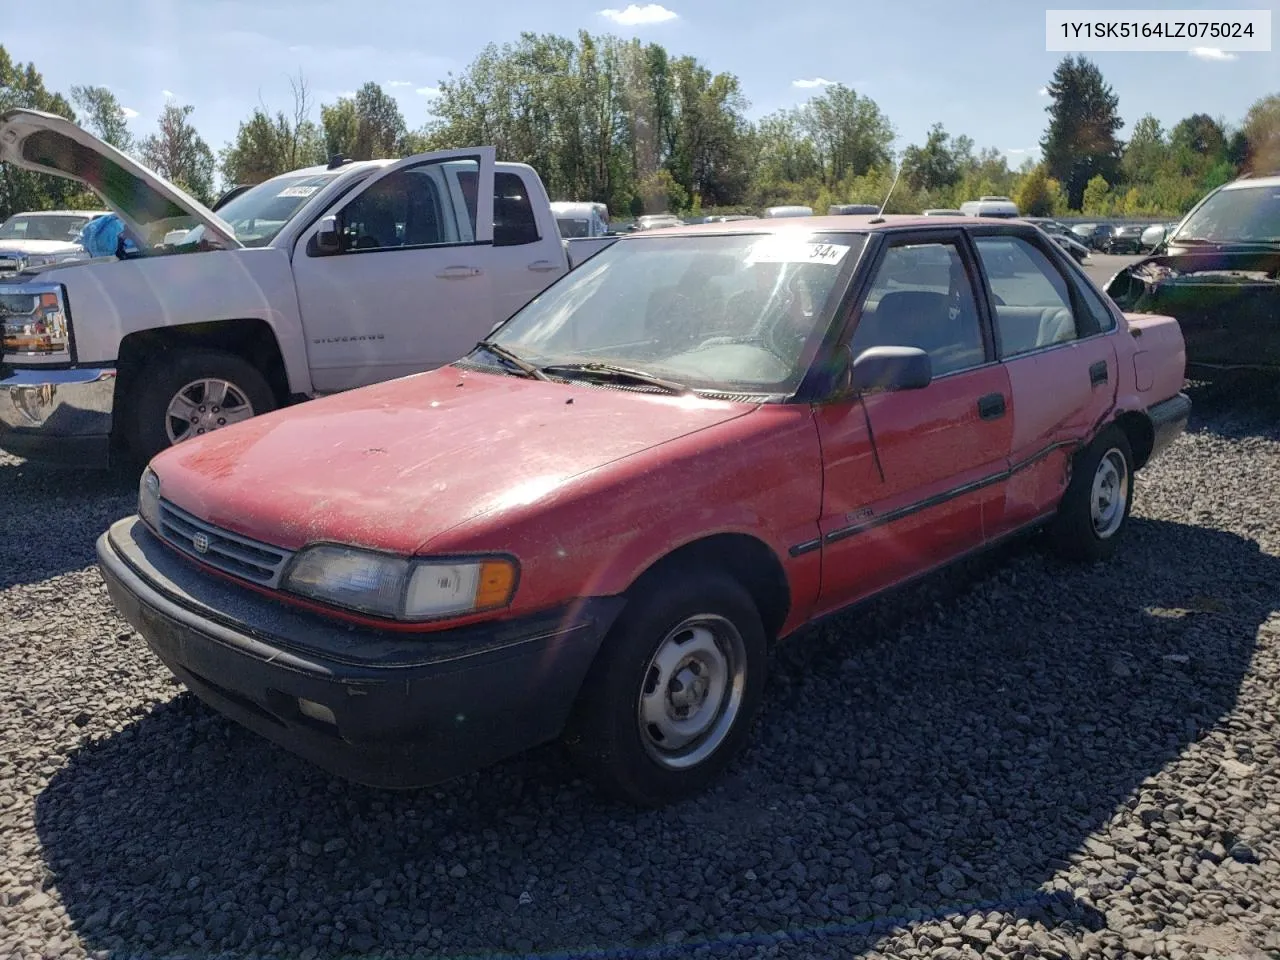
[97,517,623,788]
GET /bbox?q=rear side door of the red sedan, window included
[973,228,1119,531]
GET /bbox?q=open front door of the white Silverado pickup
[293,147,495,393]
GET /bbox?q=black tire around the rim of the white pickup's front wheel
[123,348,276,463]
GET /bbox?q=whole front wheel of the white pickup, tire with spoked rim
[125,349,276,462]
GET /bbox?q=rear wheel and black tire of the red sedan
[1050,425,1134,562]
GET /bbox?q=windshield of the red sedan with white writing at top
[475,230,867,394]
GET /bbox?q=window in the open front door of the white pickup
[338,160,479,252]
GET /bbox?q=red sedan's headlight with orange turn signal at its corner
[284,544,517,621]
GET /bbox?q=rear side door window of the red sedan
[974,236,1079,357]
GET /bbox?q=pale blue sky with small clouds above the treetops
[0,0,1280,166]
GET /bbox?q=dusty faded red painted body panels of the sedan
[154,216,1184,634]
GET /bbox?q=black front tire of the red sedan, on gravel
[566,568,767,806]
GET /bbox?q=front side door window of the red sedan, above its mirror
[850,242,987,376]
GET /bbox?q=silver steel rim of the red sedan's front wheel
[636,613,746,771]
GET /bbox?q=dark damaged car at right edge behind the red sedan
[1107,174,1280,371]
